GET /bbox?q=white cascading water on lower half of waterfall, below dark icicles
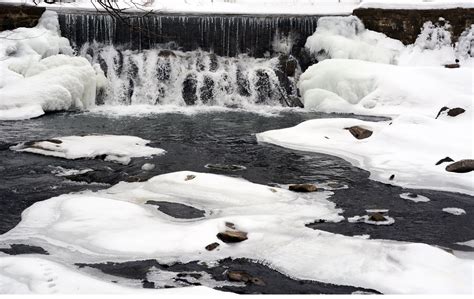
[80,43,297,107]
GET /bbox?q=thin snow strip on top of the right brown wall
[359,0,474,9]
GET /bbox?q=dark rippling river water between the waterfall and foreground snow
[0,111,474,293]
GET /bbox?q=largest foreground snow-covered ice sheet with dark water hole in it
[0,171,473,294]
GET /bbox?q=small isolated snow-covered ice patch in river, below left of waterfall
[11,135,165,165]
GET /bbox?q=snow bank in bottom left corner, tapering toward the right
[0,256,224,296]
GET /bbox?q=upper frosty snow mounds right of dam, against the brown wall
[305,16,474,66]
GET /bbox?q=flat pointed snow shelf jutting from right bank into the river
[257,114,474,195]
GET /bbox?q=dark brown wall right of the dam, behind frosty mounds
[353,8,474,45]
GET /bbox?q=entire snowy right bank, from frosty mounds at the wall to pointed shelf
[257,17,474,195]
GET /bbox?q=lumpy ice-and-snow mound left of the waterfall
[0,11,103,120]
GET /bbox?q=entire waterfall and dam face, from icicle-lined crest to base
[58,12,318,107]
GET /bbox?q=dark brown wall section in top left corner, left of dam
[0,4,45,31]
